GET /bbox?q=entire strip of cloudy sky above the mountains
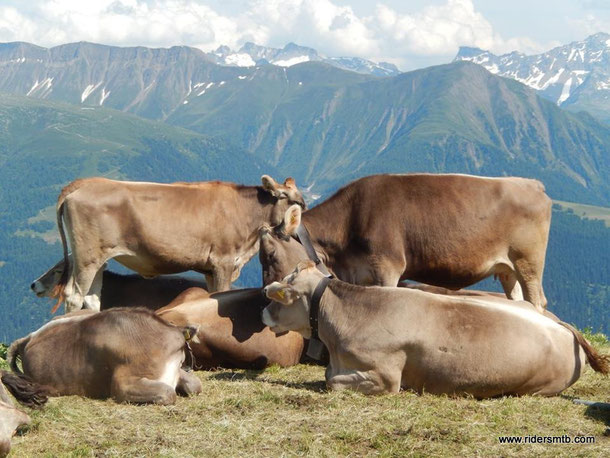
[0,0,610,70]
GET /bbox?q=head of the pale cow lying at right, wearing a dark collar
[262,261,324,339]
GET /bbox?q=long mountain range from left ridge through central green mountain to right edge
[0,39,610,205]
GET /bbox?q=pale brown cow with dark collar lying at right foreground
[263,261,610,398]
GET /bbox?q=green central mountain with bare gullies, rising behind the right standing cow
[166,62,610,205]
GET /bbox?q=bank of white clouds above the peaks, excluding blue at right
[0,0,545,68]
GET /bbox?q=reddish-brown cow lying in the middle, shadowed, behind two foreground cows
[157,288,304,369]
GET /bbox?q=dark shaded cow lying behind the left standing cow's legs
[30,254,206,313]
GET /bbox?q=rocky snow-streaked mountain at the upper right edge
[455,33,610,122]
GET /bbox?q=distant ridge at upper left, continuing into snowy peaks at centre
[0,42,398,120]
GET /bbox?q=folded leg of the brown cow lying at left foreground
[110,374,176,405]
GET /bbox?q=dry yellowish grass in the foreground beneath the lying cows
[2,338,610,457]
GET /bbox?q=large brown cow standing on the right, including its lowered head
[259,174,551,311]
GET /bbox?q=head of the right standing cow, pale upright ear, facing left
[258,205,309,285]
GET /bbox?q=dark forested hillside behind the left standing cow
[0,95,276,342]
